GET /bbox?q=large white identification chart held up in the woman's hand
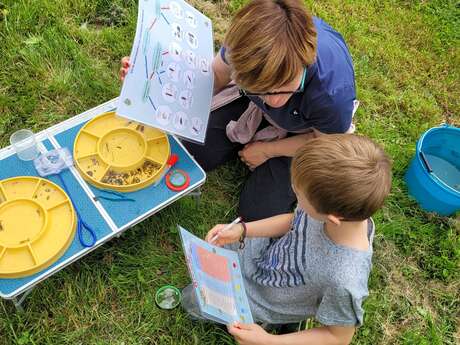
[117,0,214,143]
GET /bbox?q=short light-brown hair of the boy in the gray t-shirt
[291,134,391,220]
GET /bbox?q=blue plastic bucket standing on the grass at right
[406,125,460,216]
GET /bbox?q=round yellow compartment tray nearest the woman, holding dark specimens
[73,112,170,192]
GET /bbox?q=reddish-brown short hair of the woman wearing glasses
[224,0,317,92]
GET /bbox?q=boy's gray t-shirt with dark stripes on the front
[234,208,374,326]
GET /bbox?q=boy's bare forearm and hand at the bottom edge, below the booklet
[228,324,355,345]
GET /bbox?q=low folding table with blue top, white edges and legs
[0,99,206,310]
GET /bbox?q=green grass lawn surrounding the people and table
[0,0,460,345]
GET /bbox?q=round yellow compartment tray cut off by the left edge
[0,176,77,278]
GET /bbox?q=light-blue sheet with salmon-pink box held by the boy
[179,226,254,324]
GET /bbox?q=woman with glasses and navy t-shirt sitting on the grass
[121,0,358,221]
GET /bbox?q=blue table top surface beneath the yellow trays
[0,109,206,298]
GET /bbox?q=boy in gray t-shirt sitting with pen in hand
[206,134,391,345]
